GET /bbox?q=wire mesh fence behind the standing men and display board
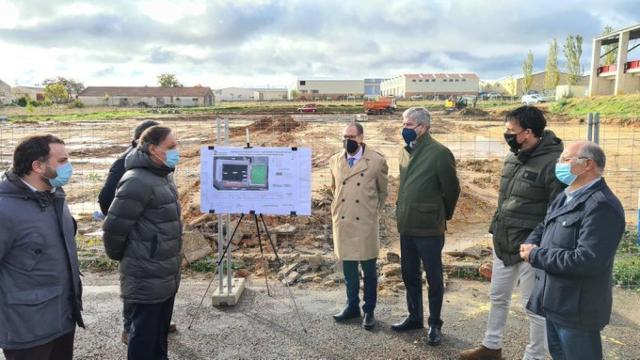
[0,112,640,288]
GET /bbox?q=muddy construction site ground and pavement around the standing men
[0,108,640,359]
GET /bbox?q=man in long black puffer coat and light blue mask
[103,126,182,360]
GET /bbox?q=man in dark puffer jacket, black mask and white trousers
[460,106,564,360]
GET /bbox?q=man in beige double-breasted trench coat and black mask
[329,123,389,330]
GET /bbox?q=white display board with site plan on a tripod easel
[200,146,311,215]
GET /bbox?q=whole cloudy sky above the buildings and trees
[0,0,640,88]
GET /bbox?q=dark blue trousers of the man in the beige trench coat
[342,258,378,314]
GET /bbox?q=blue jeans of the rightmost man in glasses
[547,319,602,360]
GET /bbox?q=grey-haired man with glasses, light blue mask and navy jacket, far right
[520,141,625,360]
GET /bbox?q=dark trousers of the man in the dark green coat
[400,235,444,328]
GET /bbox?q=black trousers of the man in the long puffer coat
[127,295,175,360]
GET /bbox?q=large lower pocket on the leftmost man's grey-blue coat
[4,286,64,343]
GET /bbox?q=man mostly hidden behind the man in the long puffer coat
[98,120,159,344]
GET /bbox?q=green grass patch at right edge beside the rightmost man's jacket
[613,231,640,290]
